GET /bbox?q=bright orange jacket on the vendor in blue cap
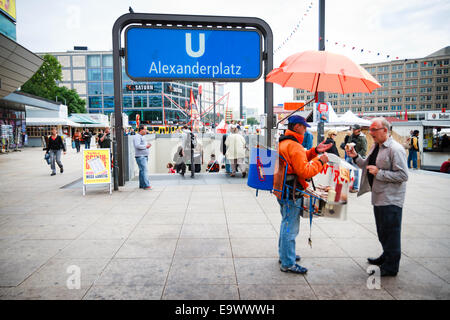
[273,130,323,197]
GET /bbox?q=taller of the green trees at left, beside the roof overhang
[21,54,62,100]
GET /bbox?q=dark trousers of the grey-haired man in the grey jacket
[373,205,403,273]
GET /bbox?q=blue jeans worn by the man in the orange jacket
[278,198,303,268]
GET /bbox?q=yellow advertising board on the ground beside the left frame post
[83,149,111,185]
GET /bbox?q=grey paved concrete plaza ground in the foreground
[0,148,450,300]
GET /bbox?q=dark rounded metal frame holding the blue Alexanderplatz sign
[112,13,273,190]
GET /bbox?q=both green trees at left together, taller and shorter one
[21,54,87,114]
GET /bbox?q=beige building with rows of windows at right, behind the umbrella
[294,46,450,120]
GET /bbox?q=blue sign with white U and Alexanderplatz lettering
[125,26,262,81]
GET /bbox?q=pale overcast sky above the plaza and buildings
[16,0,450,112]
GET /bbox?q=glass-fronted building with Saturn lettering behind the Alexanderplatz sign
[38,47,226,125]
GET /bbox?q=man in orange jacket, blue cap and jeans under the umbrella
[274,115,332,274]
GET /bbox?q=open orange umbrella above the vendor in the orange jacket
[266,50,381,94]
